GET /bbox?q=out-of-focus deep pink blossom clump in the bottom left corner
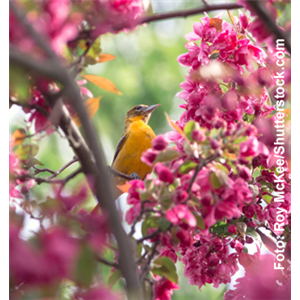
[9,220,79,285]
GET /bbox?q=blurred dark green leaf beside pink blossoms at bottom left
[75,245,97,286]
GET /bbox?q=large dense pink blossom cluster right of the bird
[134,12,290,299]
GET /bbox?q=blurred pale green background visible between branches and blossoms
[10,0,251,300]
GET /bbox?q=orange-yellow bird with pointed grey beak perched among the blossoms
[91,104,160,212]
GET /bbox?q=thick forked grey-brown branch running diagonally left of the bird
[9,0,143,299]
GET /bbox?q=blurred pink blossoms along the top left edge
[9,0,143,56]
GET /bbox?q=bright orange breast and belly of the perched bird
[112,121,155,184]
